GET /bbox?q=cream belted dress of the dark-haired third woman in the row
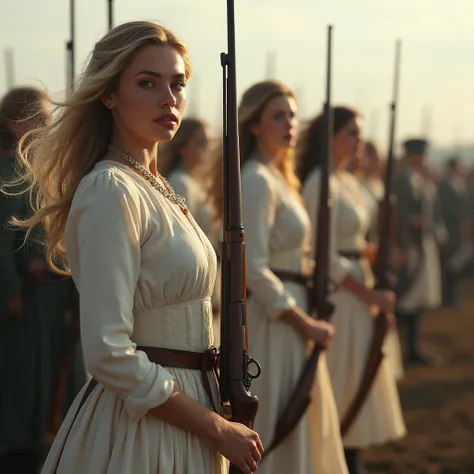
[303,169,406,448]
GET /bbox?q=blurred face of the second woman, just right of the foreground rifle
[251,95,298,156]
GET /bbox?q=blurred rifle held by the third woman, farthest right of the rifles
[341,41,401,436]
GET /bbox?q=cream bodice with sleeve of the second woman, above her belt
[242,159,311,315]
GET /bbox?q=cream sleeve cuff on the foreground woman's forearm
[124,364,175,420]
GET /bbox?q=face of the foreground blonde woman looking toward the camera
[109,45,186,146]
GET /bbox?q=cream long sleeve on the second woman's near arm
[242,170,296,318]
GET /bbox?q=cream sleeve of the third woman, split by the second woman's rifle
[303,170,351,284]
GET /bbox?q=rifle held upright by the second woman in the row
[264,26,334,457]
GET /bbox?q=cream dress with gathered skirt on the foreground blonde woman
[42,161,227,474]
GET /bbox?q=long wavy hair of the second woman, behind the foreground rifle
[211,80,300,219]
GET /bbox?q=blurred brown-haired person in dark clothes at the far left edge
[0,87,85,474]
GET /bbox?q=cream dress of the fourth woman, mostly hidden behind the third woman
[360,179,405,380]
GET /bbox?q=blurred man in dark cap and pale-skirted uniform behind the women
[394,139,446,365]
